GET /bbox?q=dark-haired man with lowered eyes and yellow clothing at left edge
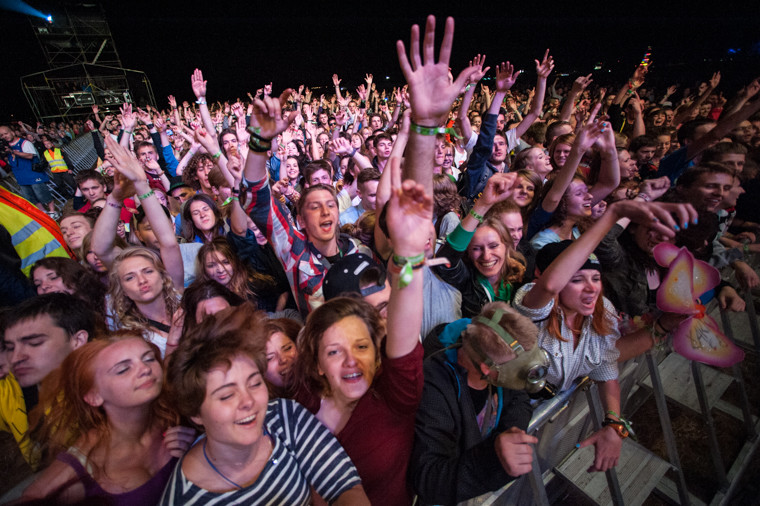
[0,293,95,468]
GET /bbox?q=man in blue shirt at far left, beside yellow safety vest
[0,126,58,219]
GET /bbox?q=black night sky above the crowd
[0,0,760,121]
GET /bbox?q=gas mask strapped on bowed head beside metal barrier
[465,309,549,394]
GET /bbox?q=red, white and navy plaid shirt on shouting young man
[247,178,372,318]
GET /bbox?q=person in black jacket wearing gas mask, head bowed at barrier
[409,302,549,504]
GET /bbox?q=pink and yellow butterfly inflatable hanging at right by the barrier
[653,243,744,367]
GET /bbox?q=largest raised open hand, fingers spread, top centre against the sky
[396,16,476,126]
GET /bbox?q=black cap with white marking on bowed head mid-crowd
[322,253,386,301]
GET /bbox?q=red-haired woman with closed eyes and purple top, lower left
[24,332,194,505]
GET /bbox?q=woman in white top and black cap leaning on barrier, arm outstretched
[514,200,696,471]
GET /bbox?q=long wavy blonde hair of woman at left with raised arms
[108,246,180,329]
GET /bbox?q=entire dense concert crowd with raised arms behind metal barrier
[0,17,760,505]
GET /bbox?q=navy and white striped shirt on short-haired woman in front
[160,399,361,505]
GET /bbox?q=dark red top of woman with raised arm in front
[296,343,424,505]
